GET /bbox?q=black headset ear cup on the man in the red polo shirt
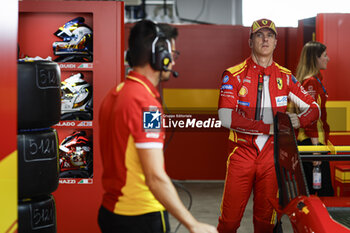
[151,23,172,71]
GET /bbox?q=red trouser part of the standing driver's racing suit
[218,137,278,233]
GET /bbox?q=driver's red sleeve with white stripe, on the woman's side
[288,75,321,128]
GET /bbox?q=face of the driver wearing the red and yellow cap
[250,28,277,57]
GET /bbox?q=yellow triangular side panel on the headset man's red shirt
[114,135,165,216]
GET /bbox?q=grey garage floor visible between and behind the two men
[170,181,293,233]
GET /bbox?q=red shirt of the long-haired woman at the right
[302,76,330,143]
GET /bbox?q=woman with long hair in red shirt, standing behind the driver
[296,41,334,196]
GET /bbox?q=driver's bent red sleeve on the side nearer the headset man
[219,71,270,135]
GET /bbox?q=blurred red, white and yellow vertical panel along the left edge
[0,1,18,232]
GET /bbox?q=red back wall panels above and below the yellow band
[125,24,298,180]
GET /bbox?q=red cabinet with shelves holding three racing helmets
[18,1,124,233]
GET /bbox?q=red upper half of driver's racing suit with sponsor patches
[219,58,319,137]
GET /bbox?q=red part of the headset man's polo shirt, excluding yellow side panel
[99,72,164,212]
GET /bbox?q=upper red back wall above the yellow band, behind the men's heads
[125,24,298,88]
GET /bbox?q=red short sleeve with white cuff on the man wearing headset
[125,96,165,149]
